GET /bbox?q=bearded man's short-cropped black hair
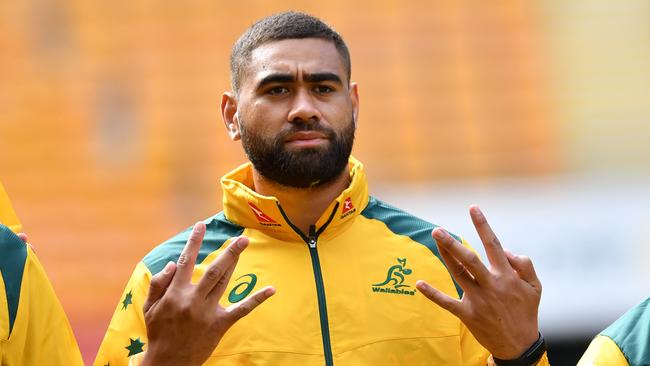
[230,11,352,92]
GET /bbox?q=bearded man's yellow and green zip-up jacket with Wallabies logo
[95,159,547,366]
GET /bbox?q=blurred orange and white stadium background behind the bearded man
[0,0,650,365]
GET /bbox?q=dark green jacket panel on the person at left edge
[0,224,27,334]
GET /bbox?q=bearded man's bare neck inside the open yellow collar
[253,165,350,234]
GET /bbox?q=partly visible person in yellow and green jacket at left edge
[0,182,83,366]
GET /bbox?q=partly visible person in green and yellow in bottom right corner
[578,298,650,366]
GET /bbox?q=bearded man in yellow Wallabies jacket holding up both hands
[95,12,547,366]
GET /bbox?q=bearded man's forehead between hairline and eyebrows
[247,38,345,82]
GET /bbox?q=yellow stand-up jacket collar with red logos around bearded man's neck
[221,157,368,240]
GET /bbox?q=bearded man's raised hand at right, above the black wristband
[416,206,542,360]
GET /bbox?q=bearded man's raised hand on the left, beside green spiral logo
[142,222,275,366]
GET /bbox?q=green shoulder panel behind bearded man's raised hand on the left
[142,212,244,275]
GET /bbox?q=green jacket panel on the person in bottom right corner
[601,298,650,366]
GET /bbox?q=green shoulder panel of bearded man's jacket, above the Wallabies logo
[361,197,463,298]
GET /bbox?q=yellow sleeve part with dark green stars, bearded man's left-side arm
[94,262,151,366]
